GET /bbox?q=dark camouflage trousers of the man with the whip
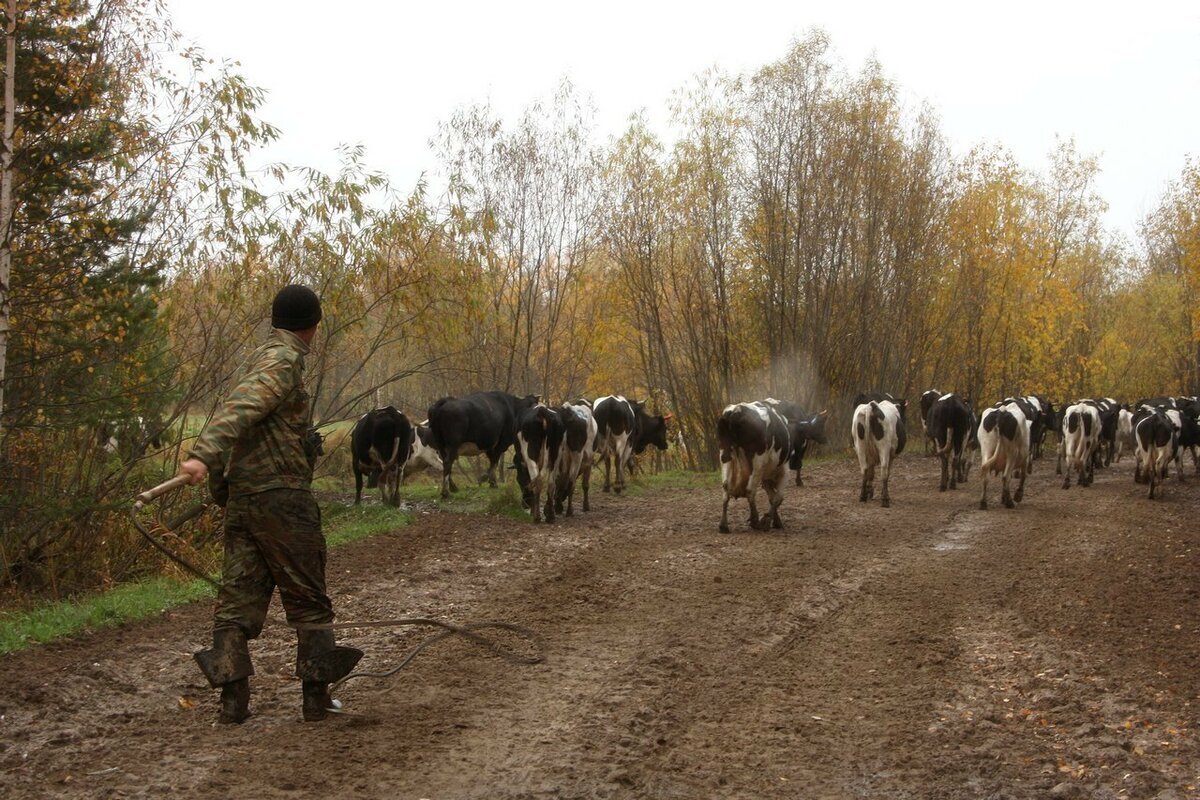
[212,489,334,639]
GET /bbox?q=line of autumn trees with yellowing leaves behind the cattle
[0,0,1200,593]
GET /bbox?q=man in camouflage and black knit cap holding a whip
[180,284,362,723]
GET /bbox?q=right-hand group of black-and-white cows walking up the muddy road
[716,390,1200,531]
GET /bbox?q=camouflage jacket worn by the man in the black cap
[187,329,312,497]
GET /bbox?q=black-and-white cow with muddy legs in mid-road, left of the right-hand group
[716,402,792,534]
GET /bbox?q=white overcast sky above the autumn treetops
[167,0,1200,236]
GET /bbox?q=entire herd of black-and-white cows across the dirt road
[350,390,1200,533]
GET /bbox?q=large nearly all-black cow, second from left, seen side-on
[428,391,539,499]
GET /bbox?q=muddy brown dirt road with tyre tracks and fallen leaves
[0,453,1200,800]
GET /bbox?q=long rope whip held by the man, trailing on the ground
[131,494,545,691]
